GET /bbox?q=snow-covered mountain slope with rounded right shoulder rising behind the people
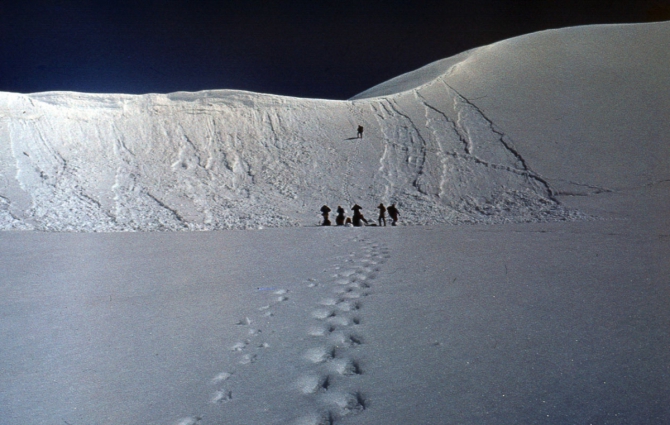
[0,23,670,231]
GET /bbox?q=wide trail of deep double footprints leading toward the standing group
[297,238,389,425]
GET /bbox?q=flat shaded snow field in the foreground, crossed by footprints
[0,196,670,425]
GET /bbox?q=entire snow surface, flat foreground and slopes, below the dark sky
[0,23,670,425]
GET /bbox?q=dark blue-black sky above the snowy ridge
[0,0,670,99]
